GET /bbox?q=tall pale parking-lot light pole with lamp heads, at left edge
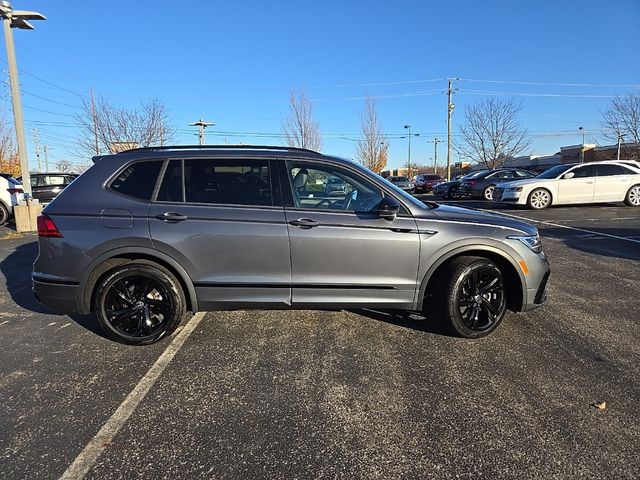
[0,0,47,196]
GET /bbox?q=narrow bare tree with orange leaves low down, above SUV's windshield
[356,96,389,173]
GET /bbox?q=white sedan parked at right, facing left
[493,161,640,210]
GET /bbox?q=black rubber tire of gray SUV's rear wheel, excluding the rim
[94,263,186,345]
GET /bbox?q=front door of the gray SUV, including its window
[282,161,420,308]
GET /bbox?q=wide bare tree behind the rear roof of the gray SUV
[76,96,175,156]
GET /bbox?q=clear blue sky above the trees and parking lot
[0,0,640,171]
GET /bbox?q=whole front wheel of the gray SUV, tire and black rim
[432,257,507,338]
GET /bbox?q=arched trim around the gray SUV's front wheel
[417,245,527,312]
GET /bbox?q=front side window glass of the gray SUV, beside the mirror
[287,163,382,212]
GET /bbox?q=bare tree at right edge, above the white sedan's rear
[602,92,640,157]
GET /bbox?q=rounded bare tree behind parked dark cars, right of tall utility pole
[454,98,531,168]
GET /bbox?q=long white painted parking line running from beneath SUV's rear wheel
[60,313,204,480]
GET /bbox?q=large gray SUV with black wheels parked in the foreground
[33,146,549,344]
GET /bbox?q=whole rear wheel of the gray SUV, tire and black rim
[94,260,187,345]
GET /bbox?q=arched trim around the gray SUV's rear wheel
[77,247,198,313]
